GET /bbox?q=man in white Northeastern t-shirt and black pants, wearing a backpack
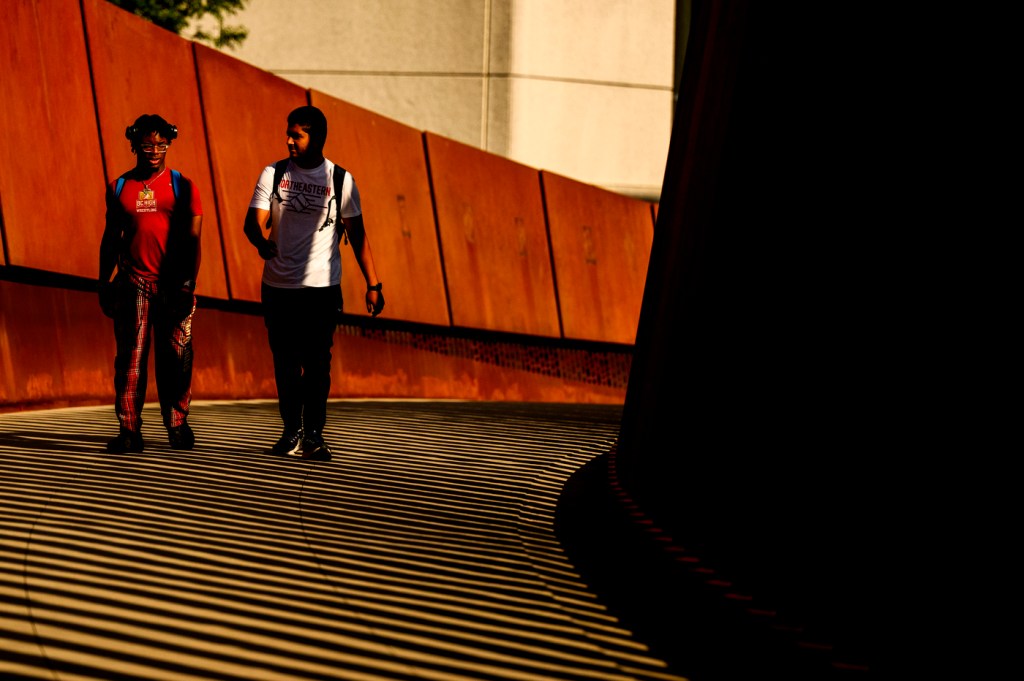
[245,107,384,461]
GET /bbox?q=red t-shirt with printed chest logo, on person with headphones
[111,168,203,282]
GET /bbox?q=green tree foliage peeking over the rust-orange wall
[109,0,249,49]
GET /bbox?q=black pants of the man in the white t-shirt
[261,284,341,432]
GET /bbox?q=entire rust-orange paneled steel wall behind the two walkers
[0,0,651,410]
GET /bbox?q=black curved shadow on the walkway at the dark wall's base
[556,453,867,681]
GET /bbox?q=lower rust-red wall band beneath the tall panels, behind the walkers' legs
[0,280,630,409]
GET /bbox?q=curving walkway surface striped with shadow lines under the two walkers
[0,400,681,681]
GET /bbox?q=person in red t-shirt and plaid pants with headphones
[98,114,203,454]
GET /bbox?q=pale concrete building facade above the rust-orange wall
[194,0,677,201]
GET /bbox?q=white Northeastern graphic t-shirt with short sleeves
[249,159,362,289]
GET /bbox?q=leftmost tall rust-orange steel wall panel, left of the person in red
[0,0,108,278]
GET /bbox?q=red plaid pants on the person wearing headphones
[114,276,196,432]
